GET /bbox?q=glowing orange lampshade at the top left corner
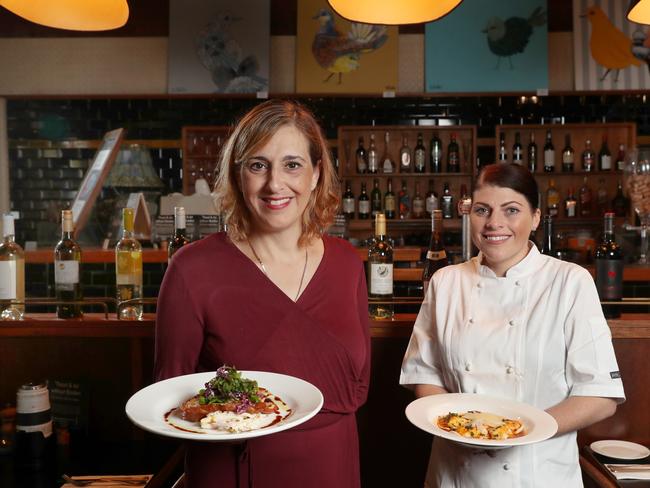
[0,0,129,31]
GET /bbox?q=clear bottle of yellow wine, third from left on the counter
[115,207,142,320]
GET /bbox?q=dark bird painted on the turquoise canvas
[482,7,546,69]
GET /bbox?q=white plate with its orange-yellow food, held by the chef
[405,393,557,449]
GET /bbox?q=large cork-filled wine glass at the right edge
[624,148,650,264]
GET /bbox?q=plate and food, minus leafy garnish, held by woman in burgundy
[126,368,323,442]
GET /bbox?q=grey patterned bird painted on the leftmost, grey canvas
[195,11,268,93]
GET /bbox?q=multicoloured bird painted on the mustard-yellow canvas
[311,9,388,84]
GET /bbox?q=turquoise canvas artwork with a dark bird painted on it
[425,0,548,92]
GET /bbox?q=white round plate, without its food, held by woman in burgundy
[126,371,323,442]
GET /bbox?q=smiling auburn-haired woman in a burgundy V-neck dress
[155,100,370,488]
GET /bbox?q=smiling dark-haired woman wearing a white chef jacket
[400,164,625,488]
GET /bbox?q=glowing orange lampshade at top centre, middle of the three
[327,0,462,25]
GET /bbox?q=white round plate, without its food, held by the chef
[405,393,557,449]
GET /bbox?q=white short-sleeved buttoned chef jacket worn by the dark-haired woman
[400,243,625,488]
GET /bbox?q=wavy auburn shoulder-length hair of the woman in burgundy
[214,99,341,245]
